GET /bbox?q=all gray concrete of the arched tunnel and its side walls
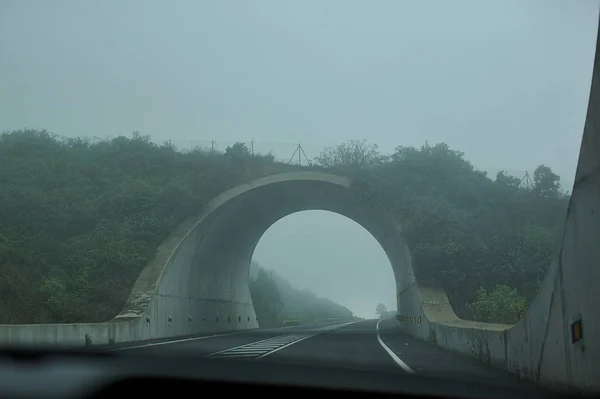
[0,10,600,391]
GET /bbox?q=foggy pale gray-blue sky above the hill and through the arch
[0,0,599,317]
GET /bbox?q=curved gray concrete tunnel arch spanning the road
[115,172,421,337]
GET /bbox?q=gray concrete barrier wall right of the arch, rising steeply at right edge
[398,18,600,392]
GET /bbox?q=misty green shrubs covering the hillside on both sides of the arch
[0,130,569,323]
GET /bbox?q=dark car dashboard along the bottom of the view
[0,348,580,399]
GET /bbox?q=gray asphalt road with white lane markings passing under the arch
[114,319,529,388]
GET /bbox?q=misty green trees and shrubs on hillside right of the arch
[316,140,569,323]
